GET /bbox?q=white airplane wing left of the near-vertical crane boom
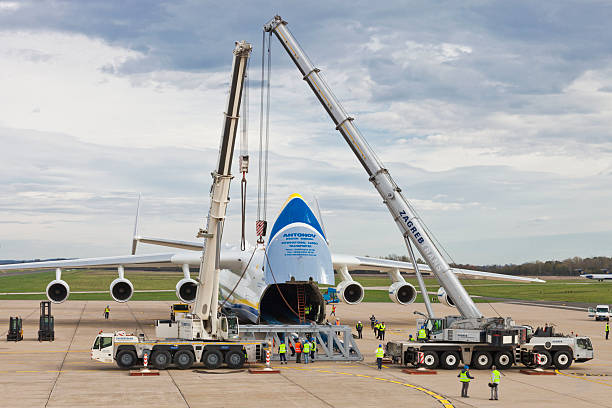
[0,253,199,271]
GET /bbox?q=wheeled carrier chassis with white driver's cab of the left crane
[91,332,267,370]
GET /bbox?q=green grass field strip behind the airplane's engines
[0,270,612,304]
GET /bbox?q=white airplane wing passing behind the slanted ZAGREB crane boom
[332,254,546,282]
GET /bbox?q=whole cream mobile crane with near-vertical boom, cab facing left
[91,41,265,369]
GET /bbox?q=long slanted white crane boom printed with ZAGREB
[264,16,482,318]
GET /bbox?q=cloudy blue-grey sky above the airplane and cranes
[0,0,612,264]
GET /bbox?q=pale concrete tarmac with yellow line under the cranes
[0,300,612,408]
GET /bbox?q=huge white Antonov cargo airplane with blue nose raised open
[0,194,543,323]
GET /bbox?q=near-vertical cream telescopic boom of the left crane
[194,41,252,337]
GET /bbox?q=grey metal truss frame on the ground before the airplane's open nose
[240,324,363,361]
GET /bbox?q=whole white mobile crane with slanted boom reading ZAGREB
[264,16,593,369]
